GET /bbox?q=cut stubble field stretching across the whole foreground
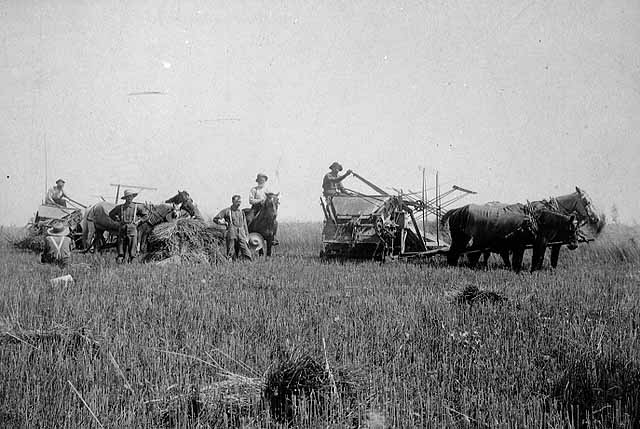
[0,224,640,428]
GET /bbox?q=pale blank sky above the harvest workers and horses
[0,0,640,225]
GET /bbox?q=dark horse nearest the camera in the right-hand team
[441,204,577,272]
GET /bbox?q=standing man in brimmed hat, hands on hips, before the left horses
[109,189,149,263]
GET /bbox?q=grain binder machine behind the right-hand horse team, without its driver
[320,173,474,261]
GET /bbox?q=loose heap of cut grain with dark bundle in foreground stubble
[147,348,368,427]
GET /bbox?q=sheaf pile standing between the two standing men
[145,219,226,263]
